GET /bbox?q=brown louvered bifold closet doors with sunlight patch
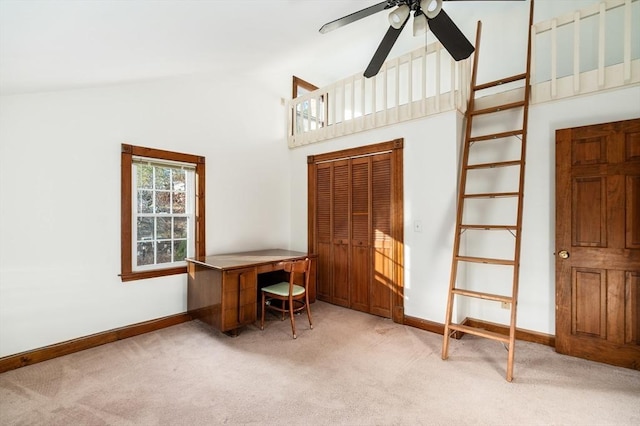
[315,153,393,318]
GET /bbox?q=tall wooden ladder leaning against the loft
[442,1,533,382]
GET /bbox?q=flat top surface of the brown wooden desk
[186,249,309,270]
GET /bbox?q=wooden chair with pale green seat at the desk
[260,258,313,339]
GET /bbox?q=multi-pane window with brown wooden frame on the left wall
[121,144,205,281]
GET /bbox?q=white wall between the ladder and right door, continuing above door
[516,86,640,334]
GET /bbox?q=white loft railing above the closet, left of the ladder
[287,43,470,148]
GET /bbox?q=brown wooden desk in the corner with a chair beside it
[187,249,316,334]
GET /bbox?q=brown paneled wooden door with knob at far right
[556,119,640,369]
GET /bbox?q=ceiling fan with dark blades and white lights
[320,0,517,78]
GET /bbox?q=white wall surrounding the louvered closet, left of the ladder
[291,112,459,322]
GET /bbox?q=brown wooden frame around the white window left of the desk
[120,143,205,281]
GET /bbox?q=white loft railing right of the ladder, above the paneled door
[531,0,640,103]
